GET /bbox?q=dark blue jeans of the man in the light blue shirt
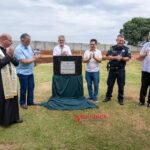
[18,74,34,105]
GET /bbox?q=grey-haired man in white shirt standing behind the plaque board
[53,35,72,56]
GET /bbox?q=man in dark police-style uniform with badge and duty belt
[104,35,131,105]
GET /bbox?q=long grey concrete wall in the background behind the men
[14,41,139,51]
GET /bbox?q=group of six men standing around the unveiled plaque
[0,33,150,126]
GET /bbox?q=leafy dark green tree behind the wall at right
[120,17,150,46]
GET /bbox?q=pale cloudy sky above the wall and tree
[0,0,150,44]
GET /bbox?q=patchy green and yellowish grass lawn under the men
[0,61,150,150]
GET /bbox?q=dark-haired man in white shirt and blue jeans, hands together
[83,39,102,101]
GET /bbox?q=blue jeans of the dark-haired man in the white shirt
[85,71,99,100]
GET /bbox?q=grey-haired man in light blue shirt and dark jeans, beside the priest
[15,33,39,109]
